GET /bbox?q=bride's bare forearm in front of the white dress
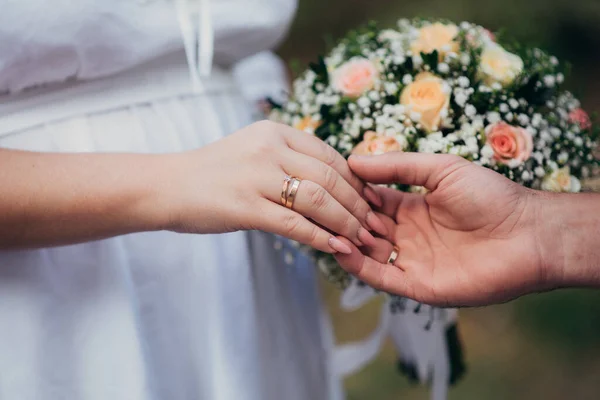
[0,149,175,249]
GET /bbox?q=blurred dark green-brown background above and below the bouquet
[279,0,600,400]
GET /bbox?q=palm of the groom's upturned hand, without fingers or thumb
[392,166,539,305]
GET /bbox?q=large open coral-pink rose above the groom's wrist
[485,122,533,163]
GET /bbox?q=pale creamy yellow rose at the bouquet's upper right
[479,43,523,86]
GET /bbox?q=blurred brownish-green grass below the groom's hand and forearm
[322,282,600,400]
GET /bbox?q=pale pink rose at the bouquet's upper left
[332,58,379,98]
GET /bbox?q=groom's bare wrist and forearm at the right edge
[536,194,600,288]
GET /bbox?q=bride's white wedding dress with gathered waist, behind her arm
[0,0,340,400]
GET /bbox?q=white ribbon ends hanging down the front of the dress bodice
[175,0,214,92]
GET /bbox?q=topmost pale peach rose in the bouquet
[410,22,459,59]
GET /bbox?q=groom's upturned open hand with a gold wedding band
[336,153,554,306]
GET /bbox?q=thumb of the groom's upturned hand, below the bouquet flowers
[348,152,470,191]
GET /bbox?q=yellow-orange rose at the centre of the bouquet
[400,72,450,132]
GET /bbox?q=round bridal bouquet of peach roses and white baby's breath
[271,19,599,394]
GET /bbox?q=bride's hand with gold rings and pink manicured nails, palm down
[168,121,386,253]
